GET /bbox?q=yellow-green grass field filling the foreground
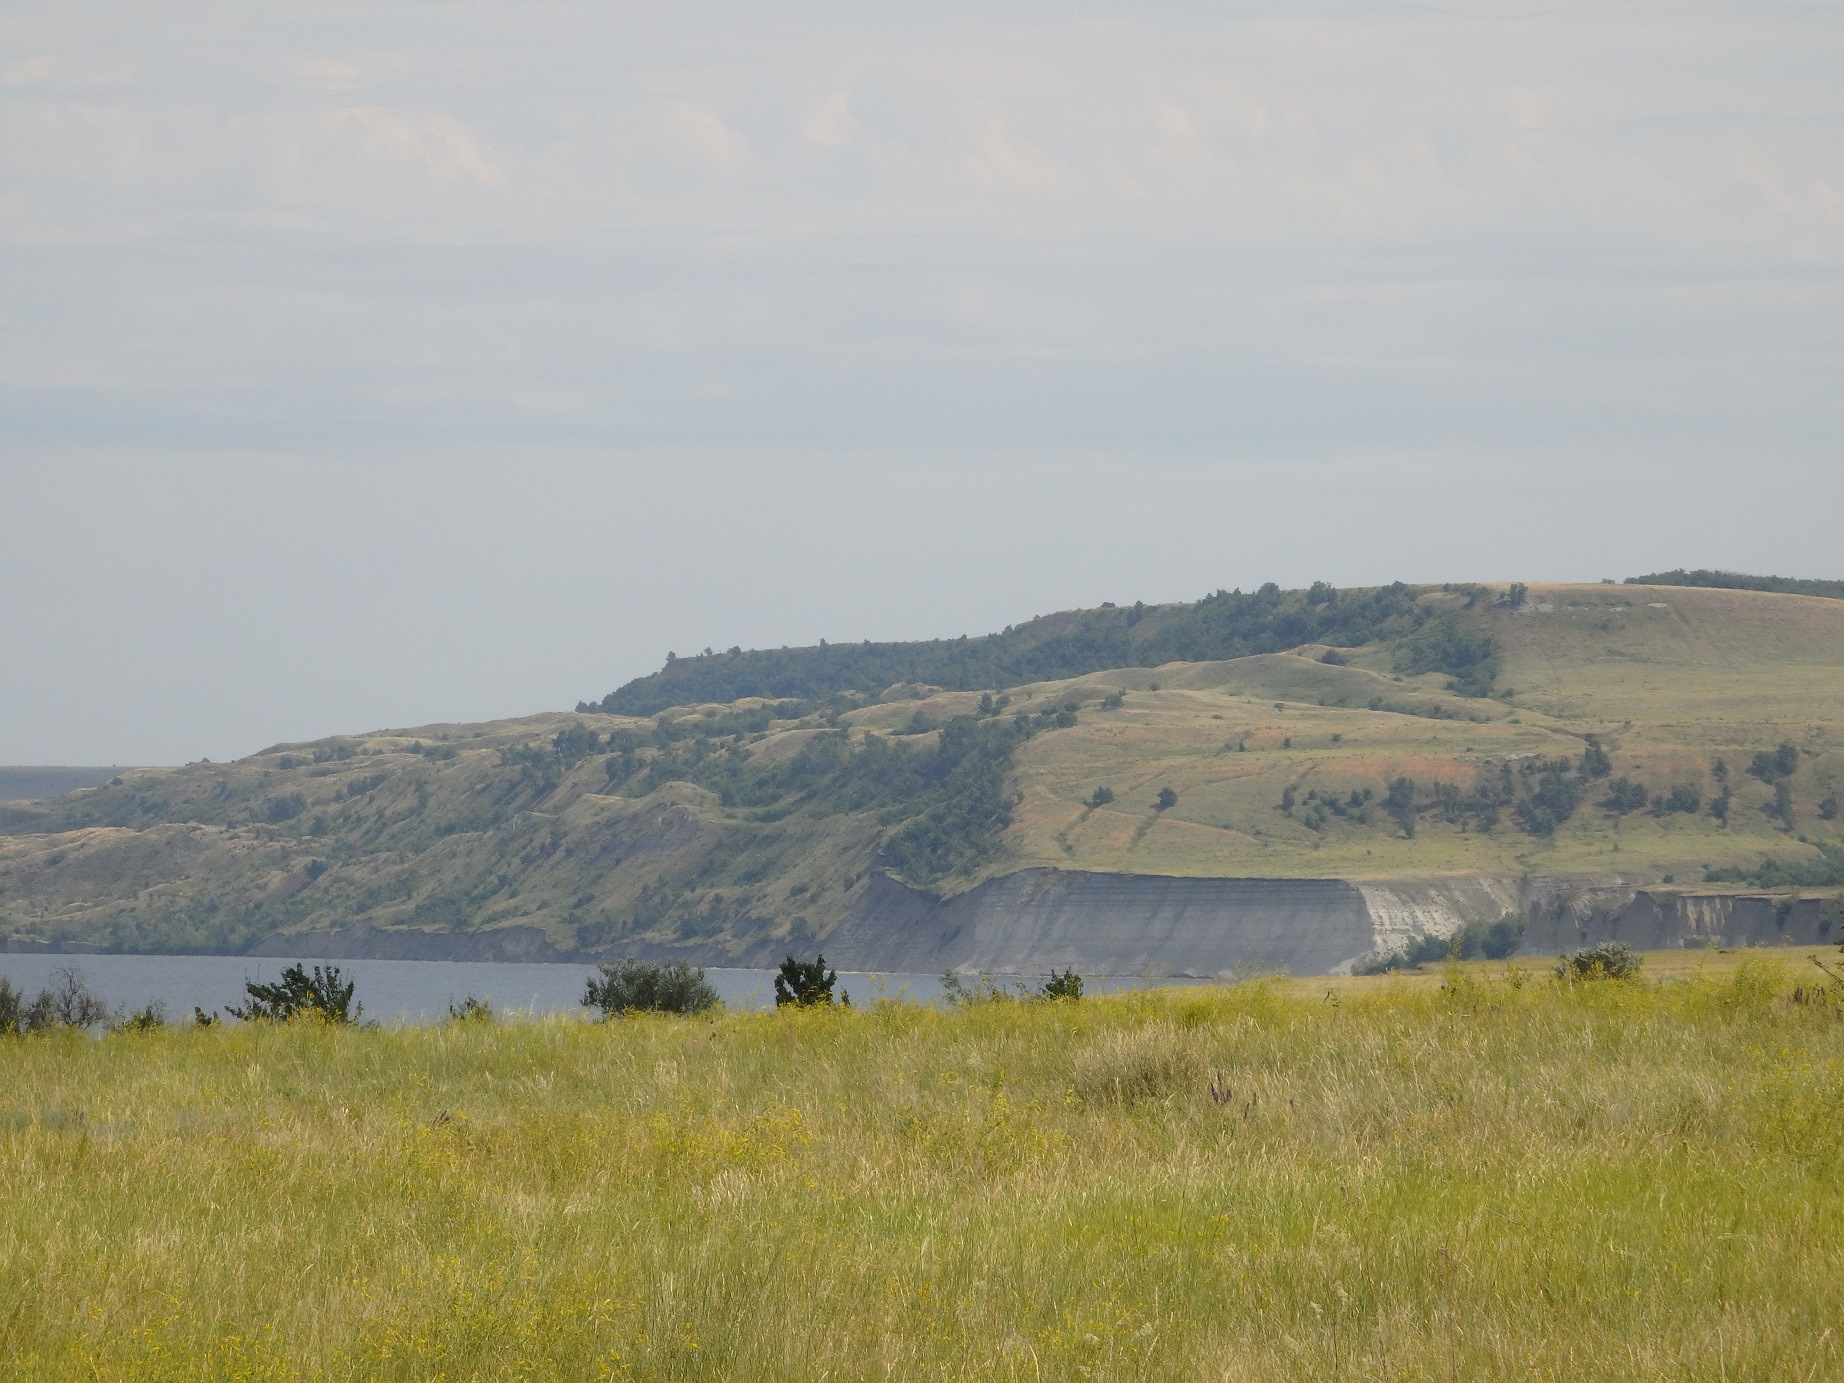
[0,953,1844,1379]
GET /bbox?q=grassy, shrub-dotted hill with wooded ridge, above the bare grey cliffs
[0,573,1844,950]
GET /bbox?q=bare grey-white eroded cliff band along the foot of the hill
[251,869,1844,979]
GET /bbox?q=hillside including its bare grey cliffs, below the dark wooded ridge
[0,586,1844,974]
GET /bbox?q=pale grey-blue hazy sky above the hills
[0,0,1844,763]
